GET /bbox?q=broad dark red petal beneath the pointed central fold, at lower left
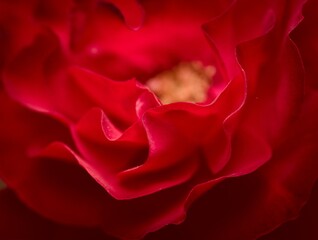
[0,136,201,239]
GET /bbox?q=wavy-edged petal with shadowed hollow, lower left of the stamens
[73,109,147,196]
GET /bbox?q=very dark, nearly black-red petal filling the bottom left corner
[0,189,114,240]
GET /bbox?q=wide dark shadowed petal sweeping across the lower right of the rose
[146,113,318,240]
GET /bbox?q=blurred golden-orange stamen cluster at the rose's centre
[146,62,215,104]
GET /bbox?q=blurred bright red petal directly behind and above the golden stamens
[74,1,232,81]
